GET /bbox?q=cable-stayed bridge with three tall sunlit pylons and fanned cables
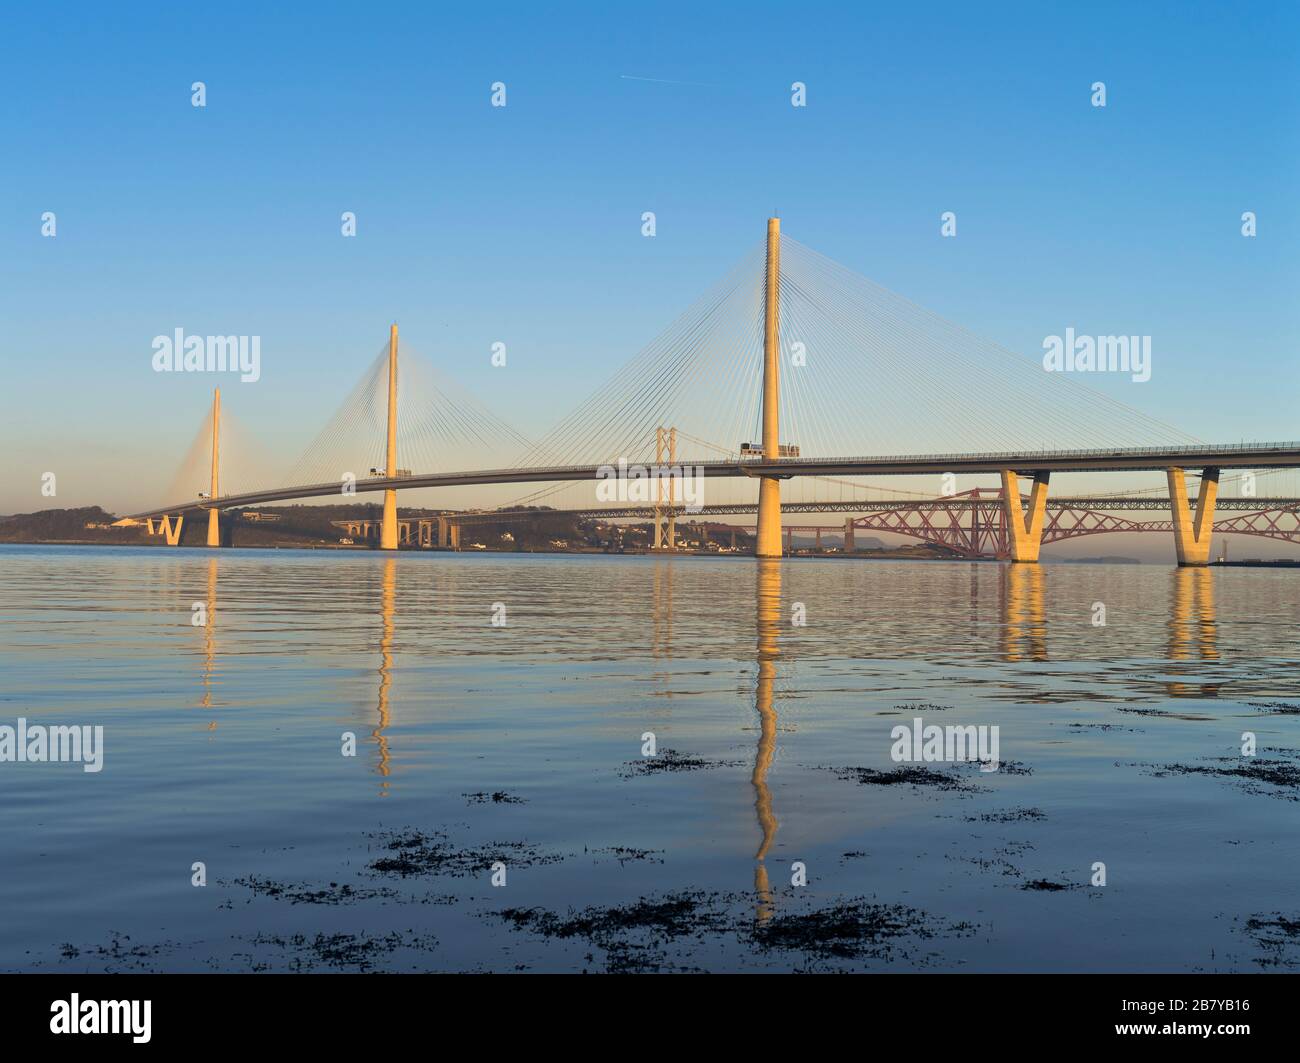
[135,218,1300,565]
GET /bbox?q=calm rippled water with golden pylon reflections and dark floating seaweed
[0,547,1300,971]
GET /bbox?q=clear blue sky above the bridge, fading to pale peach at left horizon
[0,0,1300,525]
